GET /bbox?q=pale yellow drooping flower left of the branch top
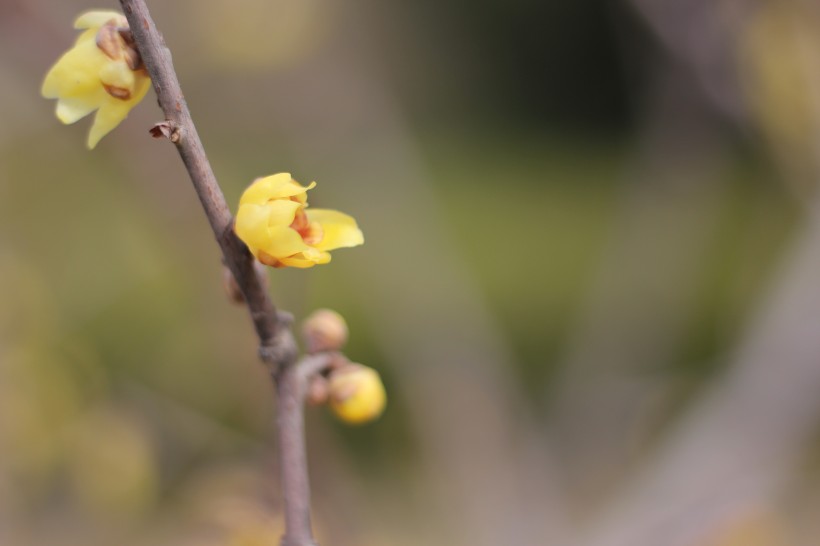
[41,11,151,148]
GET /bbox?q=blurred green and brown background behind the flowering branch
[0,0,820,546]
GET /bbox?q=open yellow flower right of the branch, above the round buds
[234,173,364,267]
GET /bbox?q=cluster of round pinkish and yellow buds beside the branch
[302,309,387,425]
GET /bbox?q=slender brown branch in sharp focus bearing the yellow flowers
[120,0,315,546]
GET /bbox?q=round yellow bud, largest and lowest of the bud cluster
[329,364,387,425]
